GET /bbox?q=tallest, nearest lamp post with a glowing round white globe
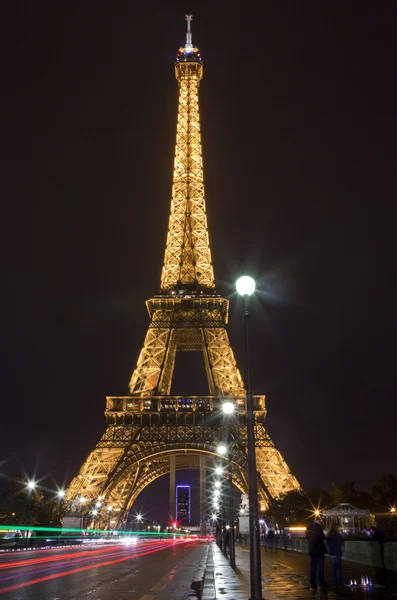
[236,276,262,600]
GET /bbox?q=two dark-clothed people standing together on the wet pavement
[307,521,344,591]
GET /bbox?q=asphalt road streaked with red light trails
[0,540,206,600]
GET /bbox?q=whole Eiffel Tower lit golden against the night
[66,15,300,531]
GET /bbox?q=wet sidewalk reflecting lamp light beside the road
[202,543,397,600]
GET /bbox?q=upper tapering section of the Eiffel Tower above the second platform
[160,15,215,293]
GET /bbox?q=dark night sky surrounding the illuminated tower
[0,0,397,516]
